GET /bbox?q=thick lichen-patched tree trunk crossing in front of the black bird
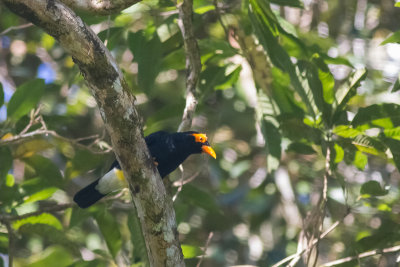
[1,0,184,267]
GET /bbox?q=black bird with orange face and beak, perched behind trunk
[74,131,216,208]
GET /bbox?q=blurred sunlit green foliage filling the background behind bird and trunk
[0,0,400,267]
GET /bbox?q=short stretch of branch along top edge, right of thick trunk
[61,0,141,15]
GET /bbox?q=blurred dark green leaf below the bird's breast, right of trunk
[179,184,219,215]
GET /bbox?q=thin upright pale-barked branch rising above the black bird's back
[178,0,201,132]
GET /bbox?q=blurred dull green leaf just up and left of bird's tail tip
[25,155,63,187]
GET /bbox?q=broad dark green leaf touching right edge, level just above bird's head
[351,104,400,126]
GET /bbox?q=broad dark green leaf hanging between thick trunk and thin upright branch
[128,31,162,91]
